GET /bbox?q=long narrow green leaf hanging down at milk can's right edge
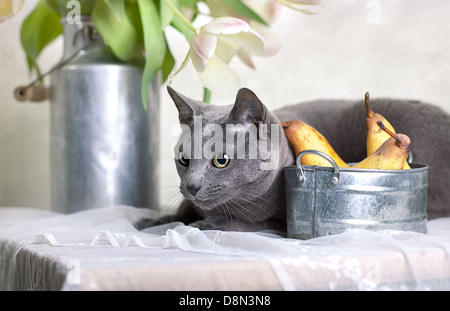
[137,0,166,109]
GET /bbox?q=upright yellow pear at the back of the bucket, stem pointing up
[364,92,411,169]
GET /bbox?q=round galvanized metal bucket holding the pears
[284,150,428,239]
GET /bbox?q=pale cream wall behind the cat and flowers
[0,0,450,209]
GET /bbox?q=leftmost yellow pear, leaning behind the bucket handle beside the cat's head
[281,120,350,167]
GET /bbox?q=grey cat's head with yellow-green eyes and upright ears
[168,87,286,218]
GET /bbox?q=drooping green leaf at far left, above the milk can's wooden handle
[20,0,62,72]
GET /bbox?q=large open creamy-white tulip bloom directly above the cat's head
[171,17,264,97]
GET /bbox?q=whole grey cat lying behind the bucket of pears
[152,87,450,231]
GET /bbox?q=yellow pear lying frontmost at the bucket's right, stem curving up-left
[352,121,411,170]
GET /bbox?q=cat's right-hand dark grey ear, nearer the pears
[228,88,266,125]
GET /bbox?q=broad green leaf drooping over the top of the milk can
[92,0,142,62]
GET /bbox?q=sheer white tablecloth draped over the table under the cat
[0,206,450,290]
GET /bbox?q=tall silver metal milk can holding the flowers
[50,19,159,213]
